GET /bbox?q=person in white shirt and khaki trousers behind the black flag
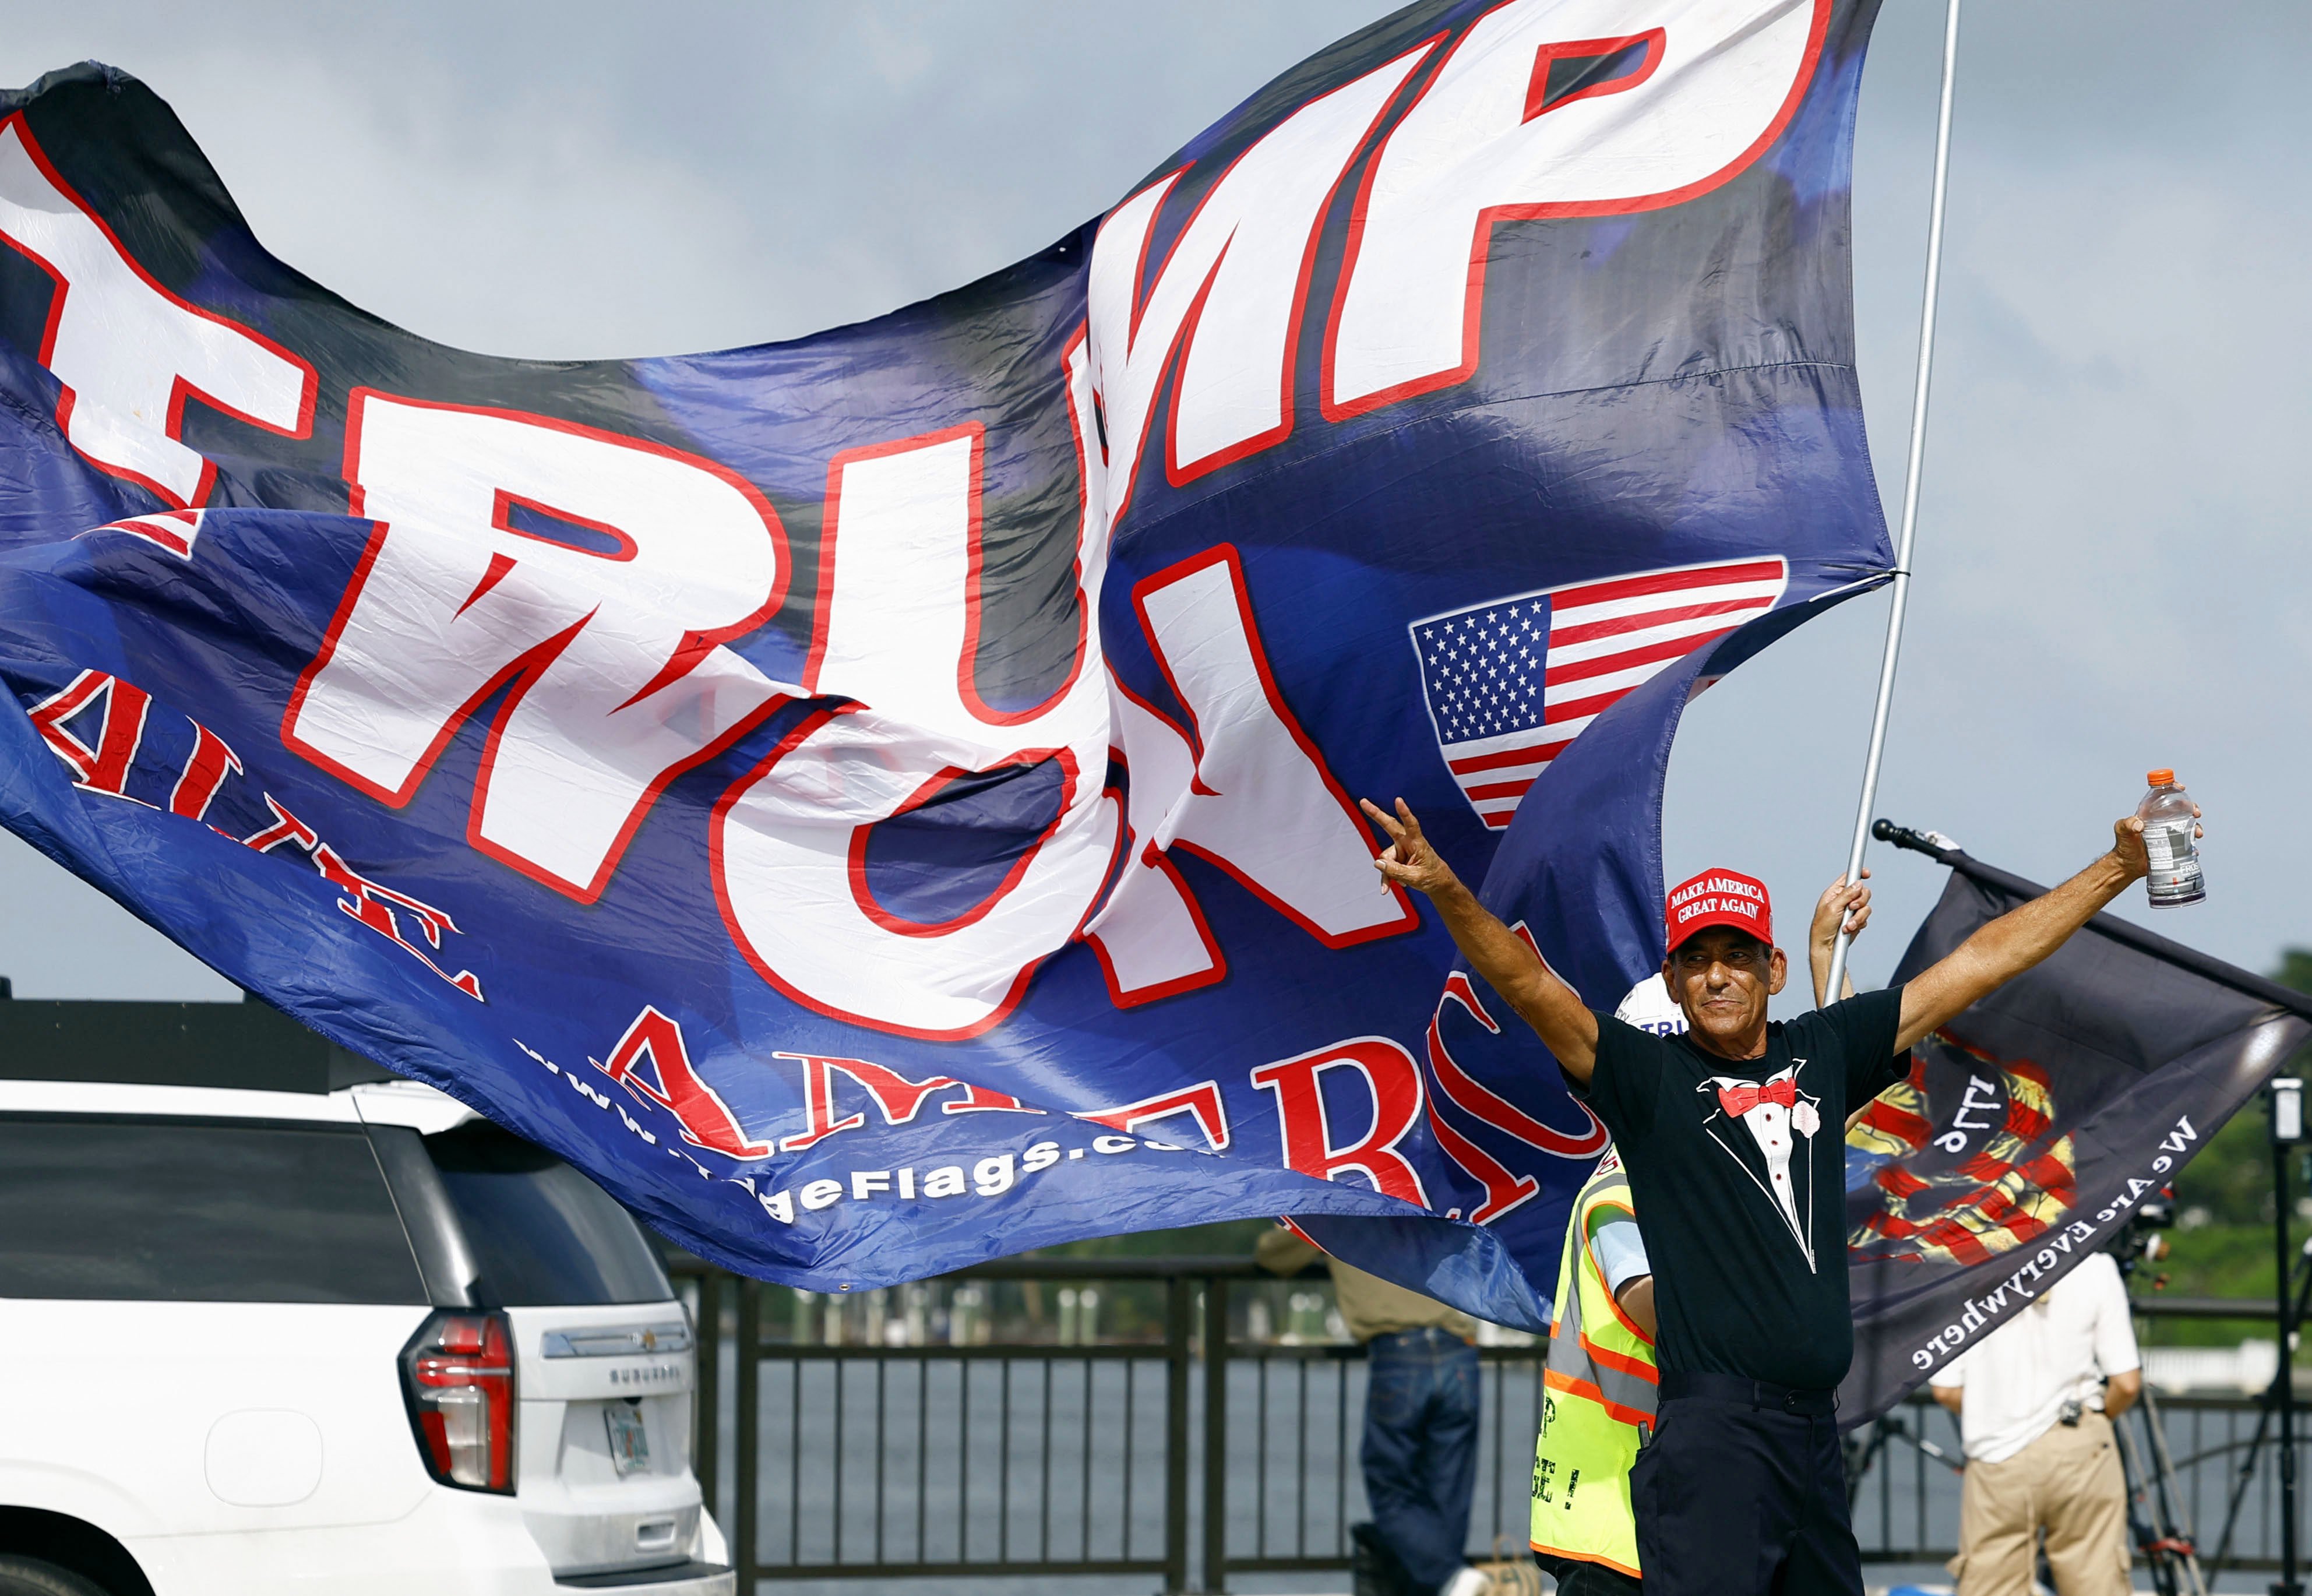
[1933,1254,2143,1596]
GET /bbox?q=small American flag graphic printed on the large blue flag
[1408,555,1789,830]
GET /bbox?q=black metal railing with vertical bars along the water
[675,1258,2312,1591]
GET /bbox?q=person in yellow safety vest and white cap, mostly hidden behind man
[1531,872,1870,1596]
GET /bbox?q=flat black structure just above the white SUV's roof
[0,988,400,1094]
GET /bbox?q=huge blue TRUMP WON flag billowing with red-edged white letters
[0,0,1889,1328]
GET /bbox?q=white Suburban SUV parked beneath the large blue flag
[0,1059,735,1596]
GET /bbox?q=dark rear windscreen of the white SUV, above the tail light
[425,1119,675,1307]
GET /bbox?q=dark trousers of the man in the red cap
[1630,1374,1863,1596]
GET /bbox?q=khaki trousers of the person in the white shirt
[1951,1411,2130,1596]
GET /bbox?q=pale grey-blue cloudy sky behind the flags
[0,0,2312,997]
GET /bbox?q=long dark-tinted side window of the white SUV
[0,1115,425,1302]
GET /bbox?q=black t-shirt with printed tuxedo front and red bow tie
[1567,988,1903,1390]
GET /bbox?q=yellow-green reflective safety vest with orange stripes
[1533,1147,1658,1577]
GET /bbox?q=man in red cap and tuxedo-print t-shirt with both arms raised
[1364,798,2191,1596]
